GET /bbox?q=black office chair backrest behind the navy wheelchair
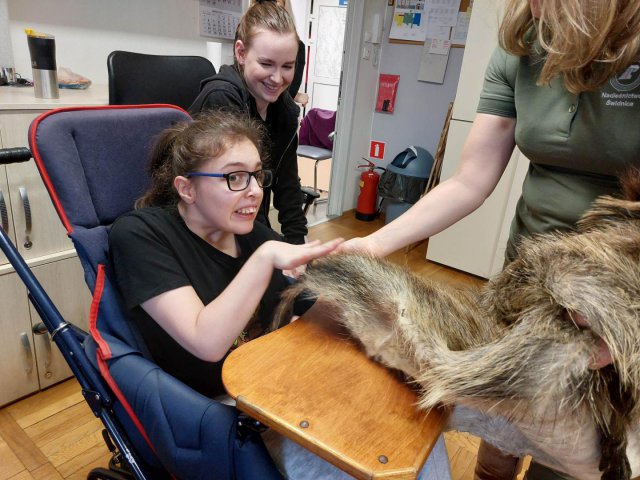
[107,50,216,110]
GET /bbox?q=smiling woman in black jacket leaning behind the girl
[189,1,307,243]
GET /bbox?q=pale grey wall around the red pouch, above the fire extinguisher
[340,0,464,211]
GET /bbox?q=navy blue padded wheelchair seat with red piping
[29,105,280,479]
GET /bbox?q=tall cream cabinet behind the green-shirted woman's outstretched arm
[427,0,529,278]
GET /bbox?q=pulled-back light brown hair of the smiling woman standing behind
[236,0,300,65]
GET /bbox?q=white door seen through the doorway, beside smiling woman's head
[302,0,347,110]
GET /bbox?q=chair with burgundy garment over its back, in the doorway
[297,108,336,203]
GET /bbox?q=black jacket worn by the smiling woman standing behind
[189,65,307,244]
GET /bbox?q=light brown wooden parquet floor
[0,212,520,480]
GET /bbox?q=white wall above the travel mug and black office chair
[7,0,219,84]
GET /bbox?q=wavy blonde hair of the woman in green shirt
[499,0,640,93]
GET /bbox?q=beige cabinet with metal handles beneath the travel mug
[0,87,107,405]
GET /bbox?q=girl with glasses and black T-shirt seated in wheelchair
[109,111,449,479]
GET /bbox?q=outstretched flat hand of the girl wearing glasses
[256,238,344,272]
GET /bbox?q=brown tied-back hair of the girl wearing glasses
[135,110,265,208]
